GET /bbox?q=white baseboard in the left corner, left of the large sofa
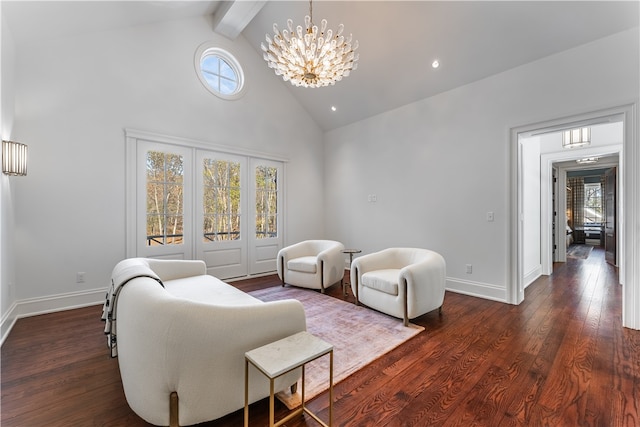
[0,289,107,345]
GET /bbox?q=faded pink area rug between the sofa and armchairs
[250,286,424,409]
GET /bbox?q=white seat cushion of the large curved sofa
[164,275,262,306]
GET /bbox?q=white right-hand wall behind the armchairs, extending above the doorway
[325,28,640,300]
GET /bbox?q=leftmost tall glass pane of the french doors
[146,151,184,246]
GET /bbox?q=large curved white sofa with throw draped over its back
[103,258,306,426]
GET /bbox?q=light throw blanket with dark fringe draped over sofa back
[102,264,164,357]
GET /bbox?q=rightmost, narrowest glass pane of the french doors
[256,166,278,239]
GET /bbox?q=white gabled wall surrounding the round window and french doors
[3,15,324,324]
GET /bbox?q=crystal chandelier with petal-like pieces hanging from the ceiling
[261,0,358,87]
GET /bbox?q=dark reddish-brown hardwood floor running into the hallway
[1,248,640,427]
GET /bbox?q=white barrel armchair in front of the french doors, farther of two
[277,240,345,293]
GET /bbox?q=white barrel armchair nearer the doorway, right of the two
[351,248,446,326]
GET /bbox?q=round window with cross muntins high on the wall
[195,44,244,99]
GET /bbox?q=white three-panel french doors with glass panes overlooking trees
[127,130,284,279]
